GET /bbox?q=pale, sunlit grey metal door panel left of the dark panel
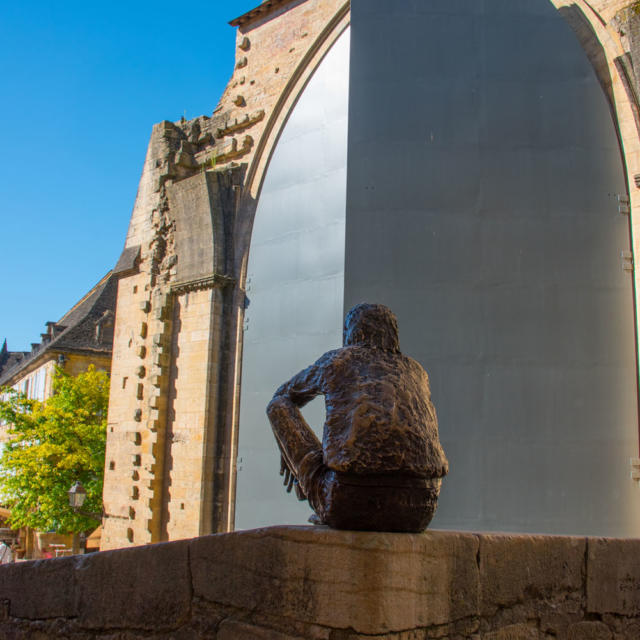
[235,33,349,529]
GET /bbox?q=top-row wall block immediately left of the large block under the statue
[77,542,191,631]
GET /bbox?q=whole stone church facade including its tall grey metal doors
[102,0,640,549]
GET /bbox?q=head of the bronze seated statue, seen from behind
[342,303,400,353]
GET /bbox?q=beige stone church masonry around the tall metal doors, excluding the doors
[100,0,640,549]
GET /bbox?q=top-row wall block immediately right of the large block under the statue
[479,534,586,615]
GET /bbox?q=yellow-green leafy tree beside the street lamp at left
[0,366,109,533]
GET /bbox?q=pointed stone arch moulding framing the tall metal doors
[222,0,640,522]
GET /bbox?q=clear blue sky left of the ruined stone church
[0,0,260,351]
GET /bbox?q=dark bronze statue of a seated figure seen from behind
[267,304,448,532]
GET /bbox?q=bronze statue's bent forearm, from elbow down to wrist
[267,397,324,508]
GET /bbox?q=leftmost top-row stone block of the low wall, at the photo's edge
[0,557,78,620]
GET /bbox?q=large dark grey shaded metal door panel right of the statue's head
[345,0,640,536]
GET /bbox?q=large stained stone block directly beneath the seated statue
[190,527,478,634]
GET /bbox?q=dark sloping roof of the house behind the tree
[0,271,118,386]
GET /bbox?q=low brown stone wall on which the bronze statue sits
[0,527,640,640]
